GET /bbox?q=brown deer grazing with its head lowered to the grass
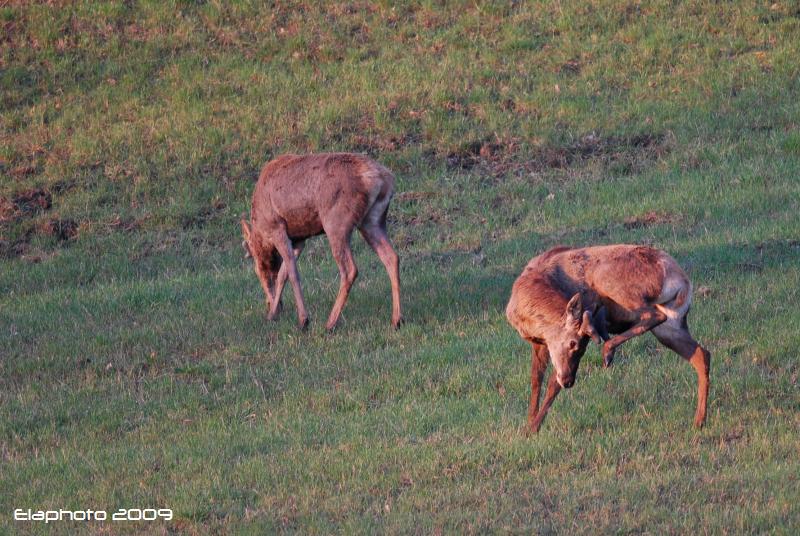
[241,153,402,331]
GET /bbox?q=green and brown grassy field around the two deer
[0,1,800,534]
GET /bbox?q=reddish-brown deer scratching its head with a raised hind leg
[506,244,711,433]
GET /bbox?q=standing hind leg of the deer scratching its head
[653,316,711,428]
